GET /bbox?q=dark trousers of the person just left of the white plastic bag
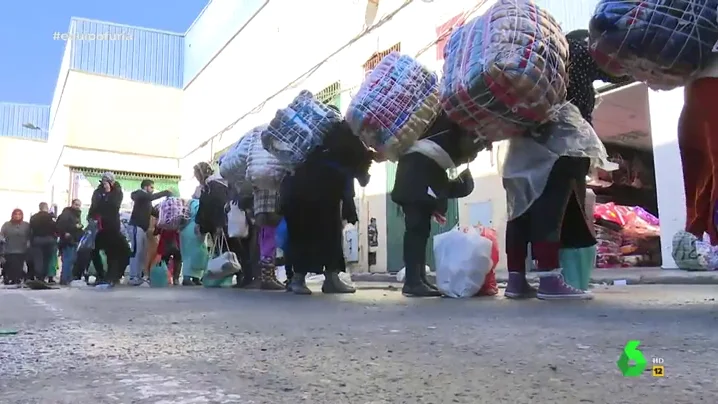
[402,205,433,284]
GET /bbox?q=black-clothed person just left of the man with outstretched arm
[87,172,130,285]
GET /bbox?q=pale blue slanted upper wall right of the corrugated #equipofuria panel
[184,0,269,87]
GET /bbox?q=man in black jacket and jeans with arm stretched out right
[129,179,172,286]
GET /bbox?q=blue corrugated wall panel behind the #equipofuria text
[69,18,184,88]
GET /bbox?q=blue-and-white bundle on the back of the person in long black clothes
[261,90,342,164]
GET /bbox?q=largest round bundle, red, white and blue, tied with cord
[441,0,568,141]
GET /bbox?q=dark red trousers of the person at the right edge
[678,78,718,245]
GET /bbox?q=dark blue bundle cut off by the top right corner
[589,0,718,89]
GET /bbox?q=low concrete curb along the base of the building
[352,269,718,285]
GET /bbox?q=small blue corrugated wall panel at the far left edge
[0,102,50,142]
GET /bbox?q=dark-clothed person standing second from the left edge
[26,202,57,289]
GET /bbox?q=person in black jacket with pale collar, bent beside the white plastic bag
[391,112,485,297]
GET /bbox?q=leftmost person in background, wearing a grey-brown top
[0,209,30,286]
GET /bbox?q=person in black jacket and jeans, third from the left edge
[57,199,83,285]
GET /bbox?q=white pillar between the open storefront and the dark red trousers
[648,88,686,269]
